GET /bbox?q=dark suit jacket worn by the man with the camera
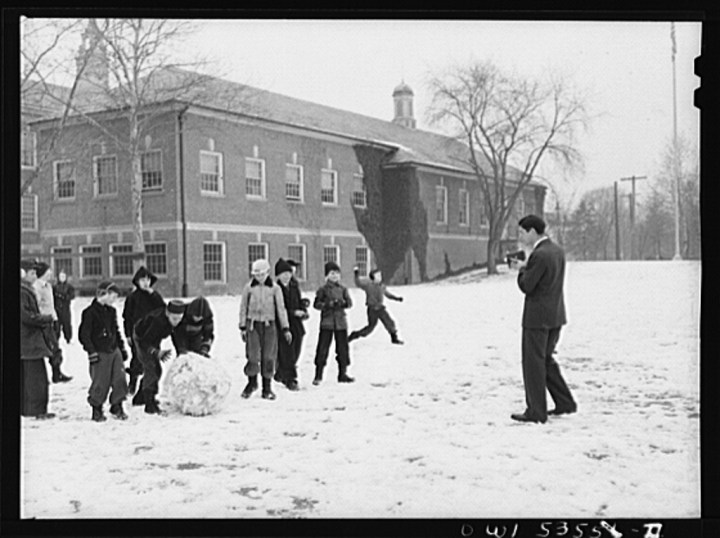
[518,239,567,329]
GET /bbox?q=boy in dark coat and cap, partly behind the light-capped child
[275,258,309,391]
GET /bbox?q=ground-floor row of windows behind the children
[51,242,370,283]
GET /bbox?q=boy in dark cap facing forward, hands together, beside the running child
[313,262,355,385]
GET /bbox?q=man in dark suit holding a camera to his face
[511,215,577,423]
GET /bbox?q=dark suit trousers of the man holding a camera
[522,327,576,422]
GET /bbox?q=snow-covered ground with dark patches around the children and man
[20,261,700,518]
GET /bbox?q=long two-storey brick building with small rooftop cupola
[22,47,545,296]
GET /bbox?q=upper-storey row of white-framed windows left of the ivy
[47,150,367,208]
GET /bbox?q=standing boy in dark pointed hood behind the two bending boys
[123,266,165,394]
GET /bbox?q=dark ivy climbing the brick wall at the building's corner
[354,145,428,280]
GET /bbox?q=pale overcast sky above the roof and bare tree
[172,20,700,203]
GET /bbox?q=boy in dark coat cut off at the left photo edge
[20,260,55,419]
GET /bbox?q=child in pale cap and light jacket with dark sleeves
[238,259,292,400]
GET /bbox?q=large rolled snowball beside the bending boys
[163,352,230,416]
